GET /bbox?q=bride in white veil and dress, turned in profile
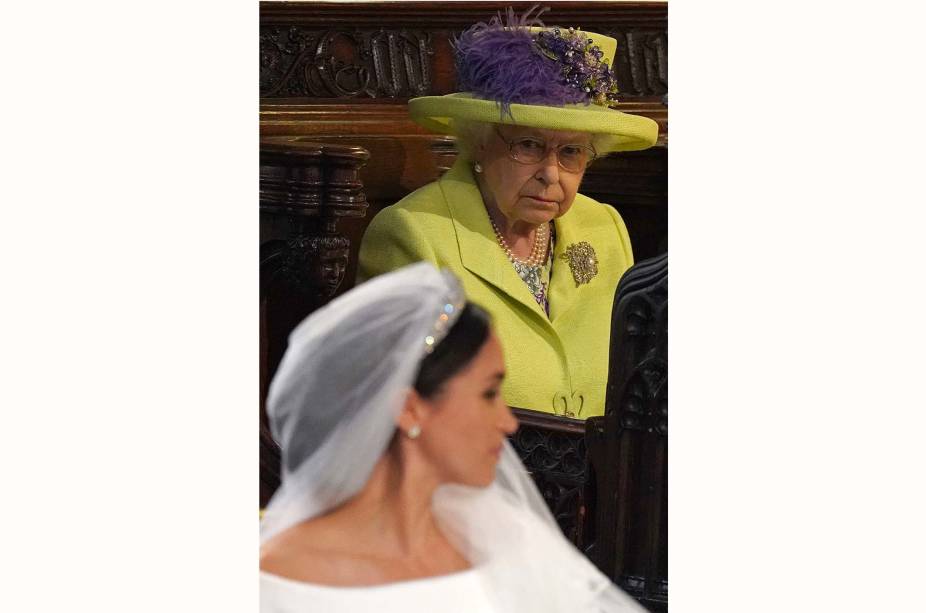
[260,263,643,613]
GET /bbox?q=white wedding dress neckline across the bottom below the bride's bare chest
[260,569,502,613]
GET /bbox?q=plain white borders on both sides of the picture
[0,0,926,613]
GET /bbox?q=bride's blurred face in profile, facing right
[419,332,518,487]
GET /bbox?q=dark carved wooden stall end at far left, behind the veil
[260,139,369,506]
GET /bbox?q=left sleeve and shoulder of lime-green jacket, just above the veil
[357,206,437,283]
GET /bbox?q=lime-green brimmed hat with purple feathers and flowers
[408,8,659,153]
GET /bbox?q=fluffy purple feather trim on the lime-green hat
[453,6,589,116]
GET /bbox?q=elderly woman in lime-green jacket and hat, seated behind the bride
[359,14,658,419]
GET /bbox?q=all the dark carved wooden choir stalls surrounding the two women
[260,2,668,611]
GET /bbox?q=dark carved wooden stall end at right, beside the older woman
[586,255,669,611]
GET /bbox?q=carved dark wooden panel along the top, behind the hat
[260,2,668,103]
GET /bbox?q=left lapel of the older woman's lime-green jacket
[440,157,556,325]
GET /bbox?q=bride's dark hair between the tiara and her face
[415,302,490,398]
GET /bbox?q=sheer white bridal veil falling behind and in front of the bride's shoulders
[261,263,644,613]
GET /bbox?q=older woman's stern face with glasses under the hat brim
[475,125,592,225]
